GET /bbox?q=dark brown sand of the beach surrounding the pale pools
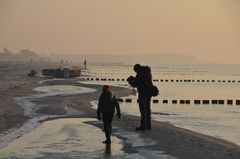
[0,63,240,159]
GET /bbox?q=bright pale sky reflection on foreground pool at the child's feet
[0,118,123,158]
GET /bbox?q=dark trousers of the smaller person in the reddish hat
[103,112,113,140]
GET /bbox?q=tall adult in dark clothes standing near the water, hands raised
[127,64,153,130]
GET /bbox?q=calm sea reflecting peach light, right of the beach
[81,64,240,145]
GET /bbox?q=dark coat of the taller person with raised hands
[128,66,153,99]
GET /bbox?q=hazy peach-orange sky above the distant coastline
[0,0,240,63]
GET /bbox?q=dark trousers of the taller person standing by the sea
[138,98,151,128]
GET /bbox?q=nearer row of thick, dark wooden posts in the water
[117,98,240,105]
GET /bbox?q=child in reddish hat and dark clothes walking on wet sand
[97,85,121,144]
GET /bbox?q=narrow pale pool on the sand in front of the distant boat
[34,85,96,96]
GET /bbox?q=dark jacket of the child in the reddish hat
[97,92,120,114]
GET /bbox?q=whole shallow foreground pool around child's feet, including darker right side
[0,118,176,159]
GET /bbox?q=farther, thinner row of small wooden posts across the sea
[83,78,240,83]
